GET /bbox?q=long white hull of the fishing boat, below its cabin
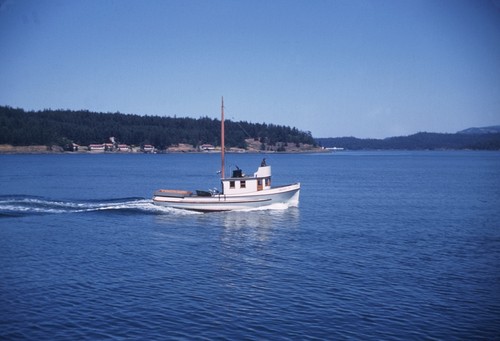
[153,183,300,212]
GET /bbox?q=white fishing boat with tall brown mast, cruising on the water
[153,98,300,212]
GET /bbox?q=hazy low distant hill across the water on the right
[316,132,500,150]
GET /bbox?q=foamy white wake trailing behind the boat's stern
[0,195,192,218]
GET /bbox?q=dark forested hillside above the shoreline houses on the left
[0,106,315,149]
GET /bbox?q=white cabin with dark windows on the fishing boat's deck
[221,165,271,195]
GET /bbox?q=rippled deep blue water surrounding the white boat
[0,152,500,340]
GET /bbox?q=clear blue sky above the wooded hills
[0,0,500,138]
